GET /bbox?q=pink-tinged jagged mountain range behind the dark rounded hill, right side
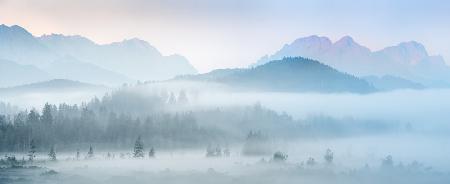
[252,35,450,87]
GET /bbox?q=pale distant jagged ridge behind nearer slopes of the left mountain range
[39,34,197,80]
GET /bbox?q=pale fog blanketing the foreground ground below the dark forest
[0,137,450,184]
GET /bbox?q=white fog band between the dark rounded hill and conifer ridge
[198,90,450,128]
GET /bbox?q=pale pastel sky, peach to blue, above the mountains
[0,0,450,72]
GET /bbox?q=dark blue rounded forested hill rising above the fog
[176,57,375,93]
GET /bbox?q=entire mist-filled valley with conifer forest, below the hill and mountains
[0,82,450,184]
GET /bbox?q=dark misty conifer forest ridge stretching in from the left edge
[0,87,398,152]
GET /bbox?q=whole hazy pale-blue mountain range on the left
[0,25,197,86]
